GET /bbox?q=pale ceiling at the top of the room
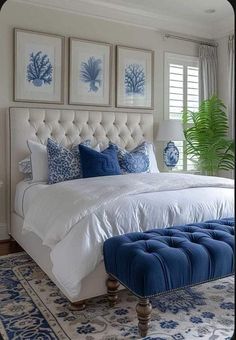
[10,0,234,39]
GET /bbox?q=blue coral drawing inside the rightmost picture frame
[125,64,145,96]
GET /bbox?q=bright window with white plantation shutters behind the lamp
[165,53,199,171]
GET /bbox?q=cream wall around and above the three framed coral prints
[0,2,197,238]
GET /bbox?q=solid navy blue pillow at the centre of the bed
[79,144,121,178]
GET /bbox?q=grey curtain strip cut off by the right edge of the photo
[228,36,235,138]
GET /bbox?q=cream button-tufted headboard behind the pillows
[8,108,153,228]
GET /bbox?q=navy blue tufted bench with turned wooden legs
[103,218,234,336]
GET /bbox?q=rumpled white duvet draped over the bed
[23,173,234,298]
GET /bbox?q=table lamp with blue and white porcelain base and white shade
[156,119,185,169]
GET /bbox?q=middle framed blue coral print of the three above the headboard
[69,38,112,106]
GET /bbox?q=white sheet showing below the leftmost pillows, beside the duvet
[15,181,48,218]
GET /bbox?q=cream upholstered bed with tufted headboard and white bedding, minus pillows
[8,108,233,302]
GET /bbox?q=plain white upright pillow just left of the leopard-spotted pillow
[27,140,48,182]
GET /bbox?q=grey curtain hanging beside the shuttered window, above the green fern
[199,44,217,102]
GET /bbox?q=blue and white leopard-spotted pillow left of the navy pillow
[47,138,90,184]
